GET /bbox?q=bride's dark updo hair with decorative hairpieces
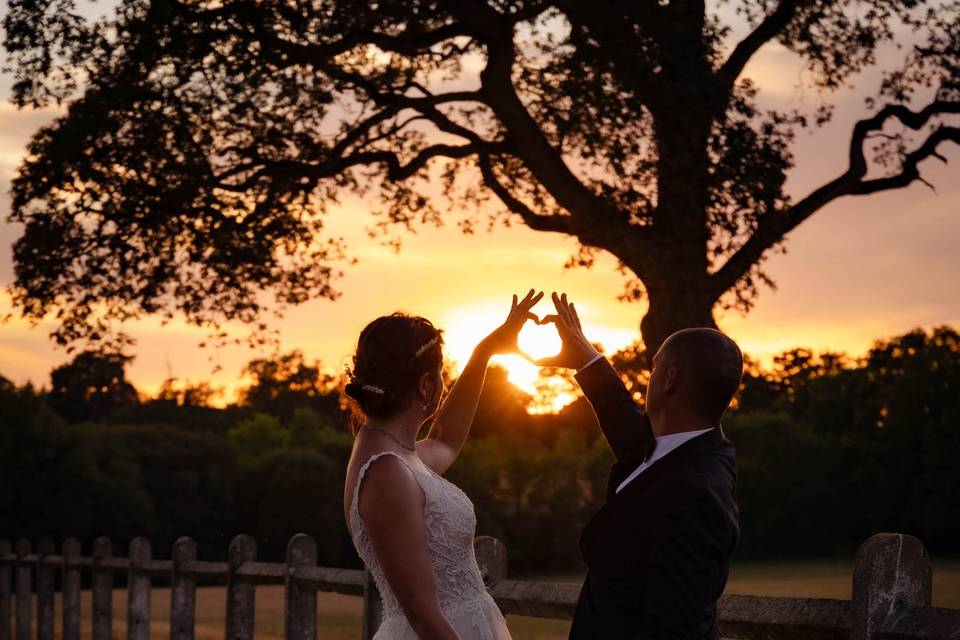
[344,312,443,421]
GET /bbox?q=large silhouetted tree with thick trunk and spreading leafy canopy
[5,0,960,356]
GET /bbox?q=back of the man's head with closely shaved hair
[654,328,743,422]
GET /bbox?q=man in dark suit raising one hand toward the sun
[537,293,743,640]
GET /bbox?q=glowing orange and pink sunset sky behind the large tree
[0,5,960,410]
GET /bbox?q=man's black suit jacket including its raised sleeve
[570,358,739,640]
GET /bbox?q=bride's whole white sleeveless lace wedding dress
[350,451,510,640]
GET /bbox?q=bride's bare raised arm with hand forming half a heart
[417,289,543,473]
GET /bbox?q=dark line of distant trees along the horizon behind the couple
[0,327,960,572]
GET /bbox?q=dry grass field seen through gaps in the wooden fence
[43,560,960,640]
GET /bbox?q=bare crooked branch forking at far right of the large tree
[711,100,960,297]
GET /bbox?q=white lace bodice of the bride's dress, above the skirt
[350,451,487,618]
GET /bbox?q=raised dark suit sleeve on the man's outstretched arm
[575,358,653,464]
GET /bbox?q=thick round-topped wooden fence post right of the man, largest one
[850,533,933,640]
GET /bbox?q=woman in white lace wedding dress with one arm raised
[344,289,543,640]
